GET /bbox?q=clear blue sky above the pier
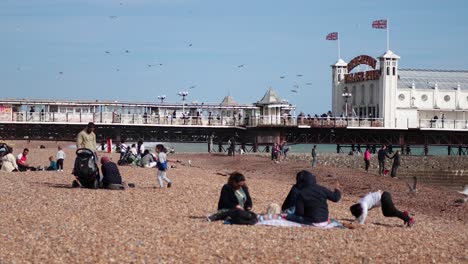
[0,0,468,114]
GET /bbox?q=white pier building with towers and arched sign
[332,50,468,129]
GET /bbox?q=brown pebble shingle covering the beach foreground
[0,141,468,263]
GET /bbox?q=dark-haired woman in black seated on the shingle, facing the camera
[207,172,252,222]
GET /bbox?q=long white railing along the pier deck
[0,112,468,130]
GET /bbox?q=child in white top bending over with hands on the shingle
[349,190,415,227]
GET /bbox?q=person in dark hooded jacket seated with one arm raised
[286,170,341,225]
